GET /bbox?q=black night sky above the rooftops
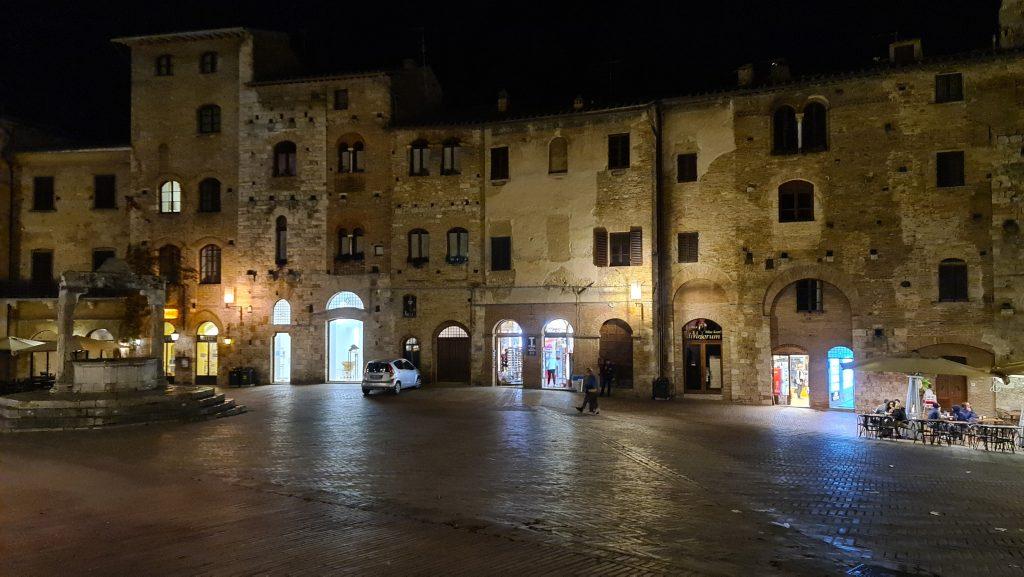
[0,0,999,143]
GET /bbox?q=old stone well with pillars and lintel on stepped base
[0,259,245,431]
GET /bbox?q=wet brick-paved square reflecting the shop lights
[0,385,1024,575]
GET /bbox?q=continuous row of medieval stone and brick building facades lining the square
[6,1,1024,412]
